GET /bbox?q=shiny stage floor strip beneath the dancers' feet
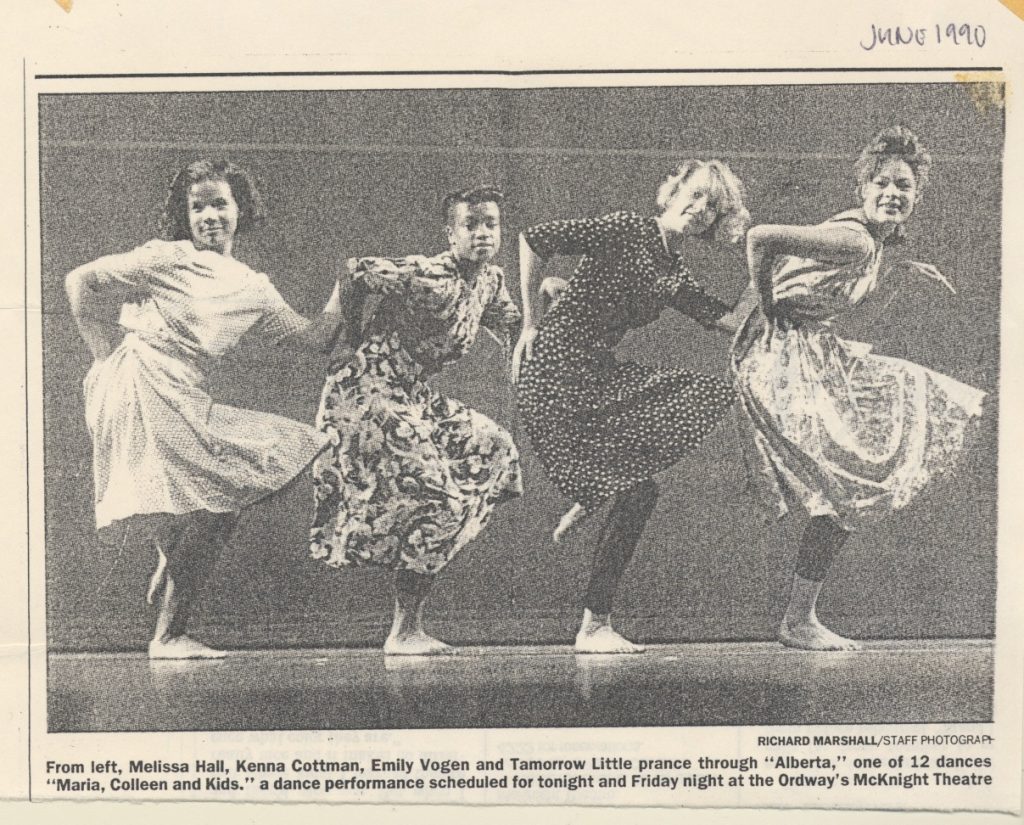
[48,640,992,732]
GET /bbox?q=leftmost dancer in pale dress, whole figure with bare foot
[67,161,341,658]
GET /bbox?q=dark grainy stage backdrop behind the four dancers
[40,85,1004,650]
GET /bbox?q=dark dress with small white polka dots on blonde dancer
[517,212,734,510]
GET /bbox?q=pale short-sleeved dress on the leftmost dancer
[85,241,328,528]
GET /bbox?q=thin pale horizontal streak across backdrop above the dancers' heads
[39,140,1002,164]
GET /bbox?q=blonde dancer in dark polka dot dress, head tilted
[513,161,749,653]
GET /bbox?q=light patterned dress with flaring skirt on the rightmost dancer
[732,210,985,529]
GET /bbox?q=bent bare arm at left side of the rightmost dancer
[746,224,871,317]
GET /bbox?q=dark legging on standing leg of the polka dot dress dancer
[584,480,657,615]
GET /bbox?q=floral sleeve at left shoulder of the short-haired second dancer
[348,255,460,311]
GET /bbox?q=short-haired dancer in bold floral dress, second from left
[310,187,522,654]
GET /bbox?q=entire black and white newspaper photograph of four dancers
[38,80,1006,734]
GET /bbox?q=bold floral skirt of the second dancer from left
[310,335,522,573]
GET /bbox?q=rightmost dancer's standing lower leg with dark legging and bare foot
[778,516,861,650]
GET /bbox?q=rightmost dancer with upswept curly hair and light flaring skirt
[733,127,984,650]
